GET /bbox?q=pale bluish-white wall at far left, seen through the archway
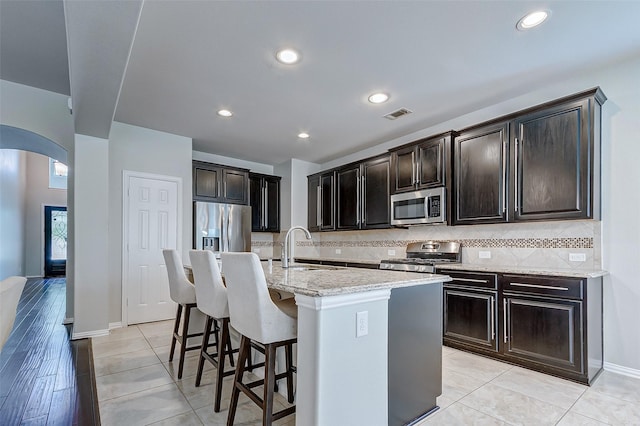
[0,149,27,280]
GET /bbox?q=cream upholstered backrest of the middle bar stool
[189,250,229,318]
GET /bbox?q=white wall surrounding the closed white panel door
[108,122,192,323]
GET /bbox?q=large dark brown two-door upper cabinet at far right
[453,88,606,225]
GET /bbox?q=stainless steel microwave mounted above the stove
[391,187,447,226]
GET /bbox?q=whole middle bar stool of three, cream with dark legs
[189,250,238,413]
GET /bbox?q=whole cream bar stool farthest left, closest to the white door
[162,249,202,379]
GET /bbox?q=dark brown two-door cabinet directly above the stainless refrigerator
[193,161,249,204]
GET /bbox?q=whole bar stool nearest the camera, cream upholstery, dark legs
[221,253,298,426]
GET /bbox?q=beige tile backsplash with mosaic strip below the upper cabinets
[252,220,602,270]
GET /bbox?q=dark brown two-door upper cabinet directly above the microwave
[390,131,455,194]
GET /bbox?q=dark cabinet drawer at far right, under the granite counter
[502,275,584,299]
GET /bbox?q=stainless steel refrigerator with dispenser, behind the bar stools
[193,201,251,257]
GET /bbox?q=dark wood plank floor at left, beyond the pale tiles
[0,278,100,426]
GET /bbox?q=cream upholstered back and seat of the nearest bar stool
[221,252,297,344]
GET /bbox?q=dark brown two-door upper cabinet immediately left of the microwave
[336,154,391,230]
